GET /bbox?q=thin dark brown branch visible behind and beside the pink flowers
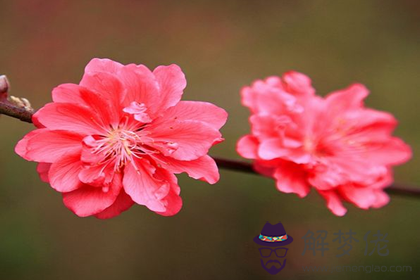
[0,73,420,196]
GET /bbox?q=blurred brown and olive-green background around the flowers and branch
[0,0,420,280]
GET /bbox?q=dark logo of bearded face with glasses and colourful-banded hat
[254,222,293,275]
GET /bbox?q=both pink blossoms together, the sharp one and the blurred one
[15,59,411,219]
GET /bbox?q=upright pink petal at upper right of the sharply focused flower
[153,64,187,110]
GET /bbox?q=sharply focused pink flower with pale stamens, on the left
[15,59,227,218]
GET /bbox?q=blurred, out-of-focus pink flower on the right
[237,72,411,216]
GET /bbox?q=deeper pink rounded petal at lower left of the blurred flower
[273,163,310,197]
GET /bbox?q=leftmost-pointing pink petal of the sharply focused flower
[15,129,82,163]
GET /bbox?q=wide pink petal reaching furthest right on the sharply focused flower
[155,101,228,129]
